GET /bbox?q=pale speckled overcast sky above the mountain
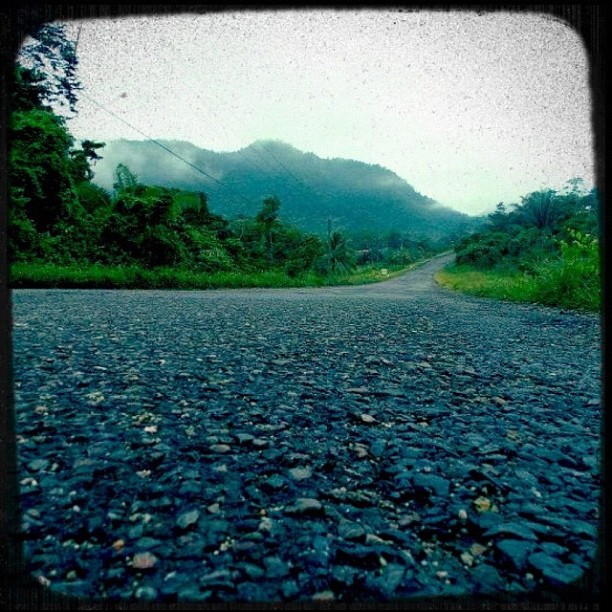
[52,9,594,214]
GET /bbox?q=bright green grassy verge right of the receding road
[435,260,601,312]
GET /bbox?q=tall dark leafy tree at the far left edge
[8,24,92,259]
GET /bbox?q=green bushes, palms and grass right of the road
[436,179,602,312]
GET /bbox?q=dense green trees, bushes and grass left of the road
[8,25,448,289]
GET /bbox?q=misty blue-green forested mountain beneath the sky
[89,140,474,239]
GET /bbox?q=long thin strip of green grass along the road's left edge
[9,263,430,289]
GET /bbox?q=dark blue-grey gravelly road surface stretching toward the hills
[12,257,601,603]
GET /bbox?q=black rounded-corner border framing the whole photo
[0,1,610,610]
